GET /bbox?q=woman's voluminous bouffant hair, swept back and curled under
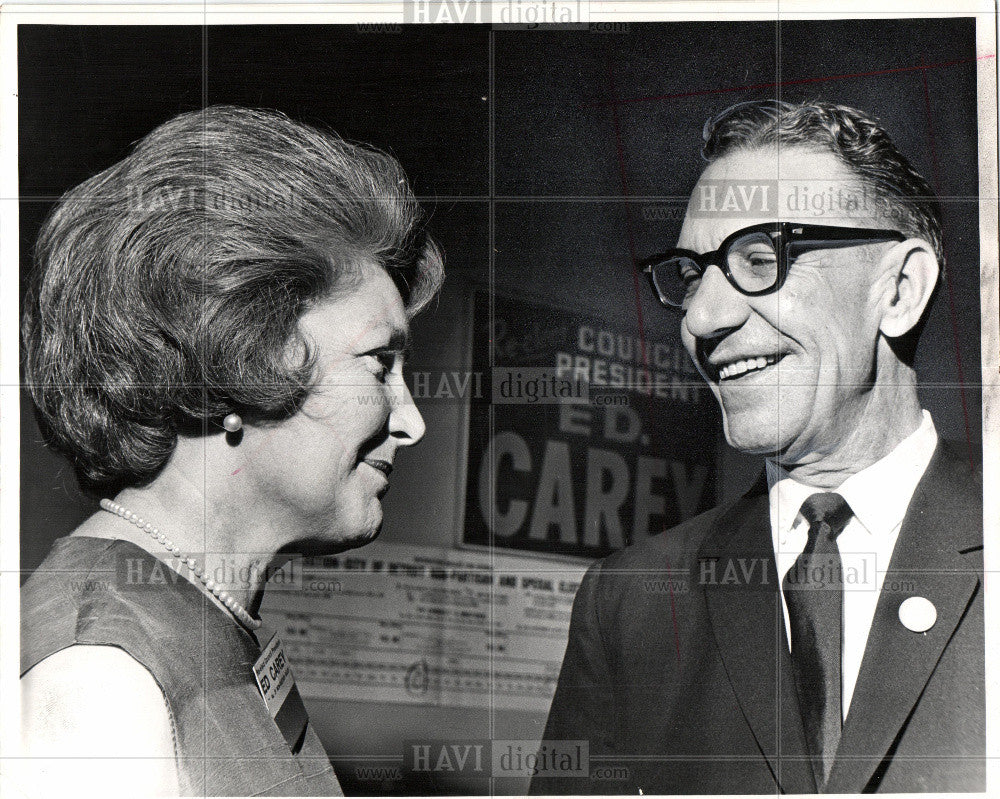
[22,106,444,492]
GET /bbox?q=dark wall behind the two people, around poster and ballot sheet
[18,19,981,793]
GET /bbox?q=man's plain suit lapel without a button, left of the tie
[699,476,816,793]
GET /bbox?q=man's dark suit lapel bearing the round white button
[825,445,982,793]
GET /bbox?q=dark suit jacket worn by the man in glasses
[531,444,985,794]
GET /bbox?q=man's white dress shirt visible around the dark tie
[766,411,938,719]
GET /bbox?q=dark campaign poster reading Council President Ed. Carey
[461,292,719,558]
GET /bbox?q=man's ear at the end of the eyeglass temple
[879,239,941,338]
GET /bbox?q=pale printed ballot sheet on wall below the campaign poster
[261,541,583,713]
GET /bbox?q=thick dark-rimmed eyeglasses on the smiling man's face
[640,222,906,311]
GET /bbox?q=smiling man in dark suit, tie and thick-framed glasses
[532,101,985,794]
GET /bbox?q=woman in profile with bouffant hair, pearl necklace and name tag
[21,106,443,795]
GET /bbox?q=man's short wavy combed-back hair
[702,100,944,268]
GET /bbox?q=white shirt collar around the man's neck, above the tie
[765,410,938,544]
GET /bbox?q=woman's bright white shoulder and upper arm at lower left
[21,644,178,795]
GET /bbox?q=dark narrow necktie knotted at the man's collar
[781,492,854,790]
